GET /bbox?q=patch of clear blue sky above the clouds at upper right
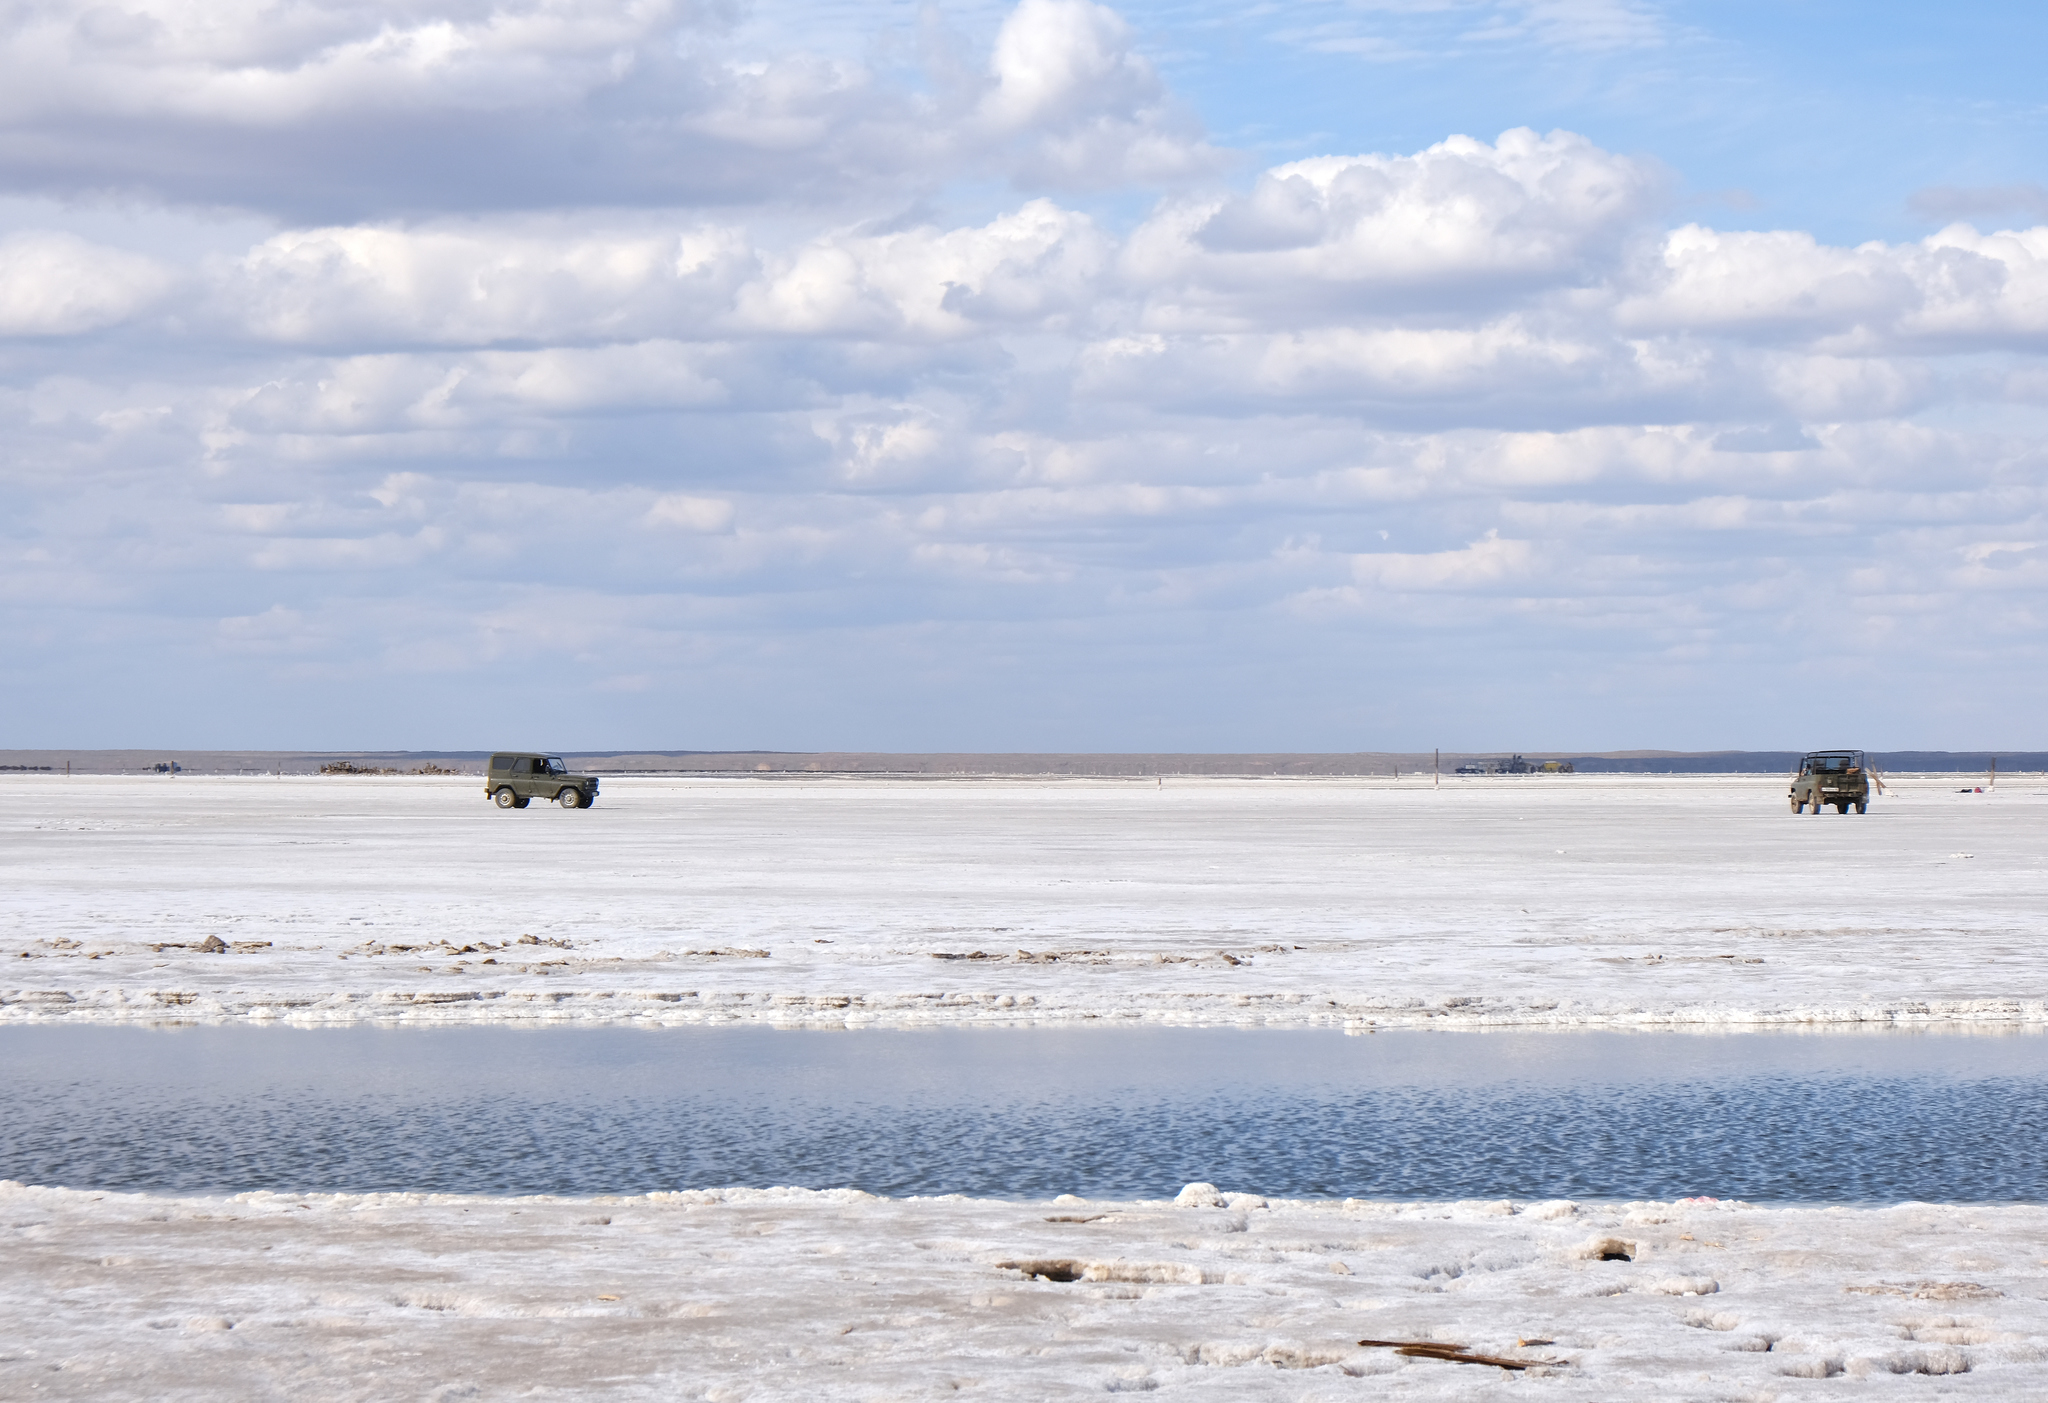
[1133,0,2048,244]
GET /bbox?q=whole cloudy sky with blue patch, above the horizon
[0,0,2048,752]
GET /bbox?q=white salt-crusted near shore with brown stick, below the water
[0,1184,2048,1403]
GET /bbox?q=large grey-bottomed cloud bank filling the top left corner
[0,0,1212,221]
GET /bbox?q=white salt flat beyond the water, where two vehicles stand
[0,776,2048,1026]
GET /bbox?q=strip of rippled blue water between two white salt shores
[0,1026,2048,1202]
